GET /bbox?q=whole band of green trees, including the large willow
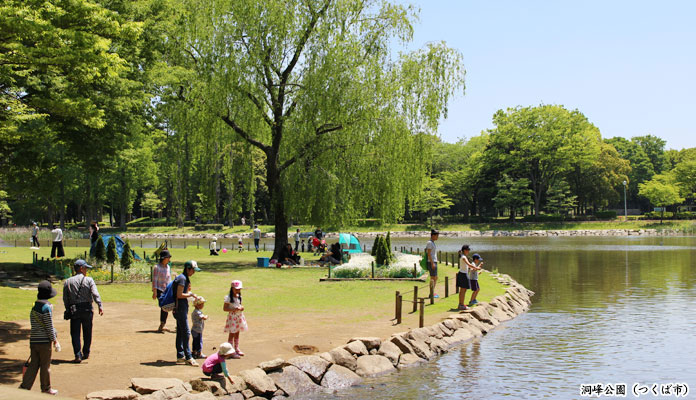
[0,0,696,248]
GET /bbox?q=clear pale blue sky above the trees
[399,0,696,149]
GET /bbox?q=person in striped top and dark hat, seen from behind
[19,281,60,395]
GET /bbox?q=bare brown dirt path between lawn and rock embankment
[0,301,444,399]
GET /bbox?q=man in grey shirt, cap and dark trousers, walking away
[63,259,104,364]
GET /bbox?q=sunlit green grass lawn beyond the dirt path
[0,247,504,322]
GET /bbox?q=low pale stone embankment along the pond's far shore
[121,229,684,240]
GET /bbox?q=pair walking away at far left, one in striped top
[19,259,104,395]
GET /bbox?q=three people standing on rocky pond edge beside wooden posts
[425,229,483,311]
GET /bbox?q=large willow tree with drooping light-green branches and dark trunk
[176,0,464,256]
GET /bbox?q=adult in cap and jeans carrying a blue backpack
[172,260,201,367]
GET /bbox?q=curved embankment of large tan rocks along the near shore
[87,274,534,400]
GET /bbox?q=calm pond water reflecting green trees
[294,237,696,400]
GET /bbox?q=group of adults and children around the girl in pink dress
[152,249,248,376]
